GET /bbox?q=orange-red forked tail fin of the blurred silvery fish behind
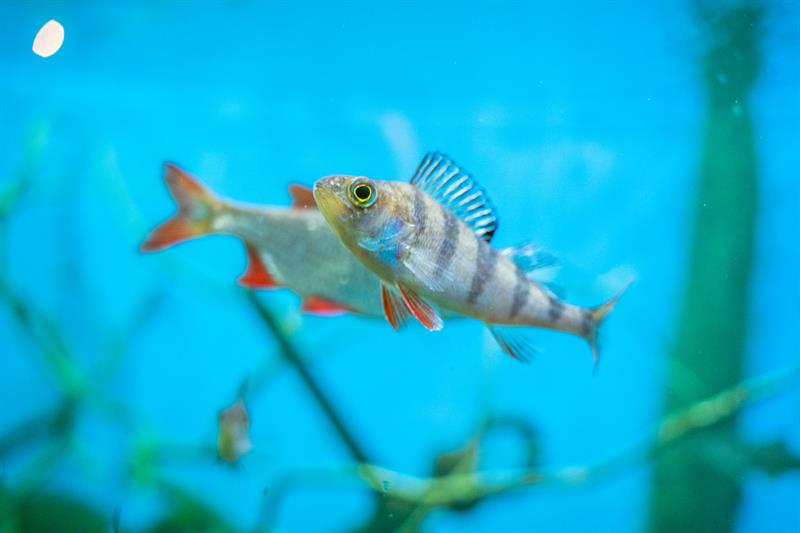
[140,163,218,252]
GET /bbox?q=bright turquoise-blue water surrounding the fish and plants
[0,1,800,532]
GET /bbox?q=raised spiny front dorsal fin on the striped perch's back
[411,152,497,242]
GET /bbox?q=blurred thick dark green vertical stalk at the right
[648,2,762,533]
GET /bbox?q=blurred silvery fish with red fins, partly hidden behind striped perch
[140,163,383,317]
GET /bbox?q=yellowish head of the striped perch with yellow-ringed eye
[314,175,404,250]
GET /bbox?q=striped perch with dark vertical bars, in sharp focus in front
[313,152,622,368]
